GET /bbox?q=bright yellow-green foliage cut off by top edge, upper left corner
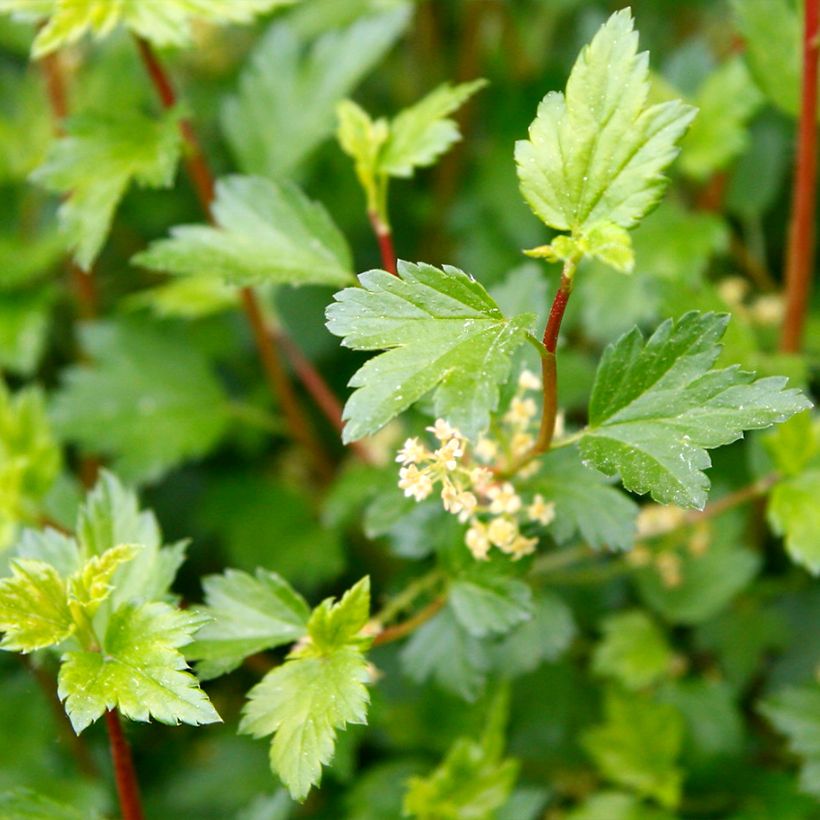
[0,0,296,58]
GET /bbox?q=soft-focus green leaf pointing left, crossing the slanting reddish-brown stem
[132,176,353,285]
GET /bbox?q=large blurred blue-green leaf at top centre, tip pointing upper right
[222,6,409,179]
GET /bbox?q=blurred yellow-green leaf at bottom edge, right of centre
[404,738,518,820]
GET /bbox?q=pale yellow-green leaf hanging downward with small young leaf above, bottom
[239,578,370,800]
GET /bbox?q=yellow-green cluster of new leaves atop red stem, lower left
[0,474,220,734]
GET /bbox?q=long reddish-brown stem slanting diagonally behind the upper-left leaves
[136,37,341,478]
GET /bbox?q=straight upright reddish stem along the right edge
[780,0,820,353]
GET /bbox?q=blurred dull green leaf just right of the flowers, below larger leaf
[528,447,638,550]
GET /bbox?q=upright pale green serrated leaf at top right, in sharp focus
[515,9,695,247]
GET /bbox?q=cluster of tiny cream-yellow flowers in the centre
[396,370,555,560]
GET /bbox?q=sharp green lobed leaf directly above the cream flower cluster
[327,262,533,441]
